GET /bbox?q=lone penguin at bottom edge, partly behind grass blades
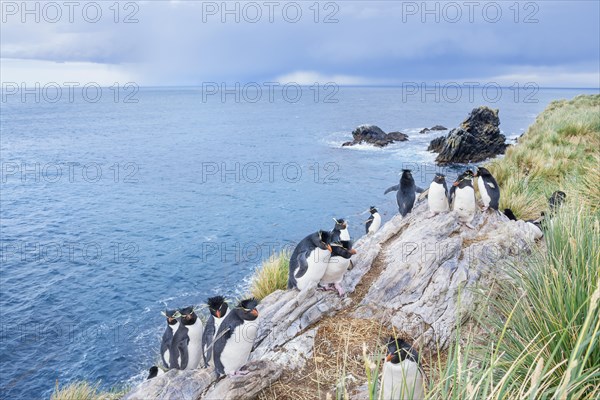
[381,337,425,400]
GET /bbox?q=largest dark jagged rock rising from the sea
[428,106,508,165]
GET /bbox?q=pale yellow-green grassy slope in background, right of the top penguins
[487,95,600,219]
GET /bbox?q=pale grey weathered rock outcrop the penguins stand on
[125,202,533,400]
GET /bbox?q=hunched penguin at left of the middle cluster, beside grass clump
[287,231,332,290]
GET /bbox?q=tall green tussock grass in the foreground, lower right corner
[427,206,600,400]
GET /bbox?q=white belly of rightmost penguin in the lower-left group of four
[221,318,260,374]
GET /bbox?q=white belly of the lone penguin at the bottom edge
[381,360,425,400]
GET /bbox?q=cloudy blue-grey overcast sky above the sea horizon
[0,0,600,87]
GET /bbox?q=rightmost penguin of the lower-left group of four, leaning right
[214,299,259,376]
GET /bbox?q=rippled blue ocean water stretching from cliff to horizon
[0,87,598,399]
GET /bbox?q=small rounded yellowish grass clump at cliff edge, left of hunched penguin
[250,250,290,300]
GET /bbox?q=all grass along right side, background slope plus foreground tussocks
[427,95,600,400]
